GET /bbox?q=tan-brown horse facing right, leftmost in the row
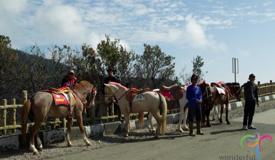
[21,81,96,154]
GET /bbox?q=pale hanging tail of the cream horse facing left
[158,93,167,135]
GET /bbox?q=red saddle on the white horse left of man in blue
[160,84,184,100]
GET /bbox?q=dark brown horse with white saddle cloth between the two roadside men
[200,83,241,126]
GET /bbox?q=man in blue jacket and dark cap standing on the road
[186,74,203,136]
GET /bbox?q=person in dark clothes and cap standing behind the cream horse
[102,67,121,120]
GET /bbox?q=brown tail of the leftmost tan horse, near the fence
[21,100,31,144]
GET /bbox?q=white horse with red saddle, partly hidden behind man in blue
[160,84,188,133]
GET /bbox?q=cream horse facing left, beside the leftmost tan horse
[104,82,167,137]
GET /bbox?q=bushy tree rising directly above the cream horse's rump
[135,44,175,87]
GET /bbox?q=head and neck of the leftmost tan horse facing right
[73,81,97,108]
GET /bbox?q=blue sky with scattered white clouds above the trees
[0,0,275,83]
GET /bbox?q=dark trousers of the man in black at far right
[243,100,256,126]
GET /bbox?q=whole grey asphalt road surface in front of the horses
[0,101,275,160]
